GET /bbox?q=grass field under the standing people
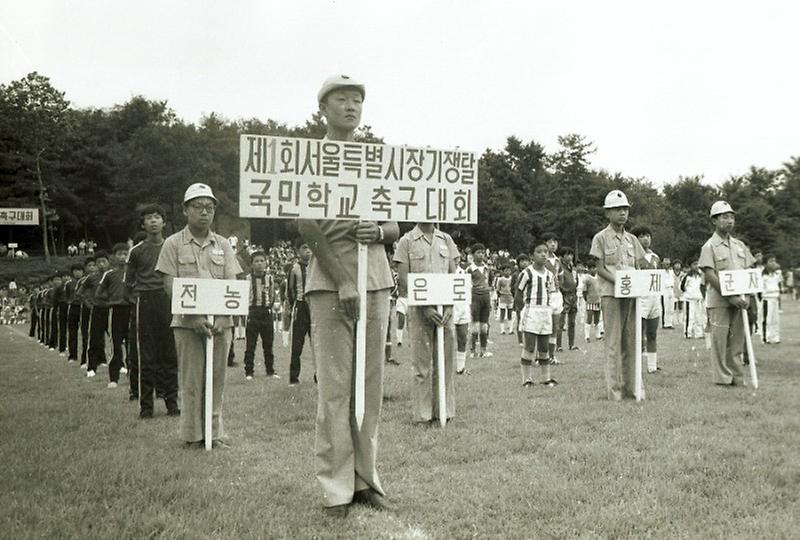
[0,300,800,538]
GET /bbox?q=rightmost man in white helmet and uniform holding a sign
[699,201,754,386]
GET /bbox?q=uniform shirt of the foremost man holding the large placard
[306,219,393,294]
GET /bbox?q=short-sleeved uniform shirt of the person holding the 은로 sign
[394,226,458,274]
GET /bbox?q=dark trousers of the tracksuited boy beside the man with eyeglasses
[136,290,180,412]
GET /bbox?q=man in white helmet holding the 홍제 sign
[590,189,645,401]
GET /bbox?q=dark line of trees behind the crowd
[0,72,800,265]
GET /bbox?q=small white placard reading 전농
[172,278,250,315]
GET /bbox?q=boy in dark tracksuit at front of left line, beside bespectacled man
[125,204,180,420]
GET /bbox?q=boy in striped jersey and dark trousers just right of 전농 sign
[244,250,280,381]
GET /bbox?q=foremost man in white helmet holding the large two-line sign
[298,75,400,517]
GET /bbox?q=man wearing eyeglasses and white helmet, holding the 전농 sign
[156,184,242,448]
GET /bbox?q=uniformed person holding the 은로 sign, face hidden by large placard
[394,223,456,424]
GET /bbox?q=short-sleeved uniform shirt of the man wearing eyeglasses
[156,225,242,328]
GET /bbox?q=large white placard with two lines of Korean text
[239,135,478,223]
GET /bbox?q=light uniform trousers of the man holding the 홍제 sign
[600,296,637,401]
